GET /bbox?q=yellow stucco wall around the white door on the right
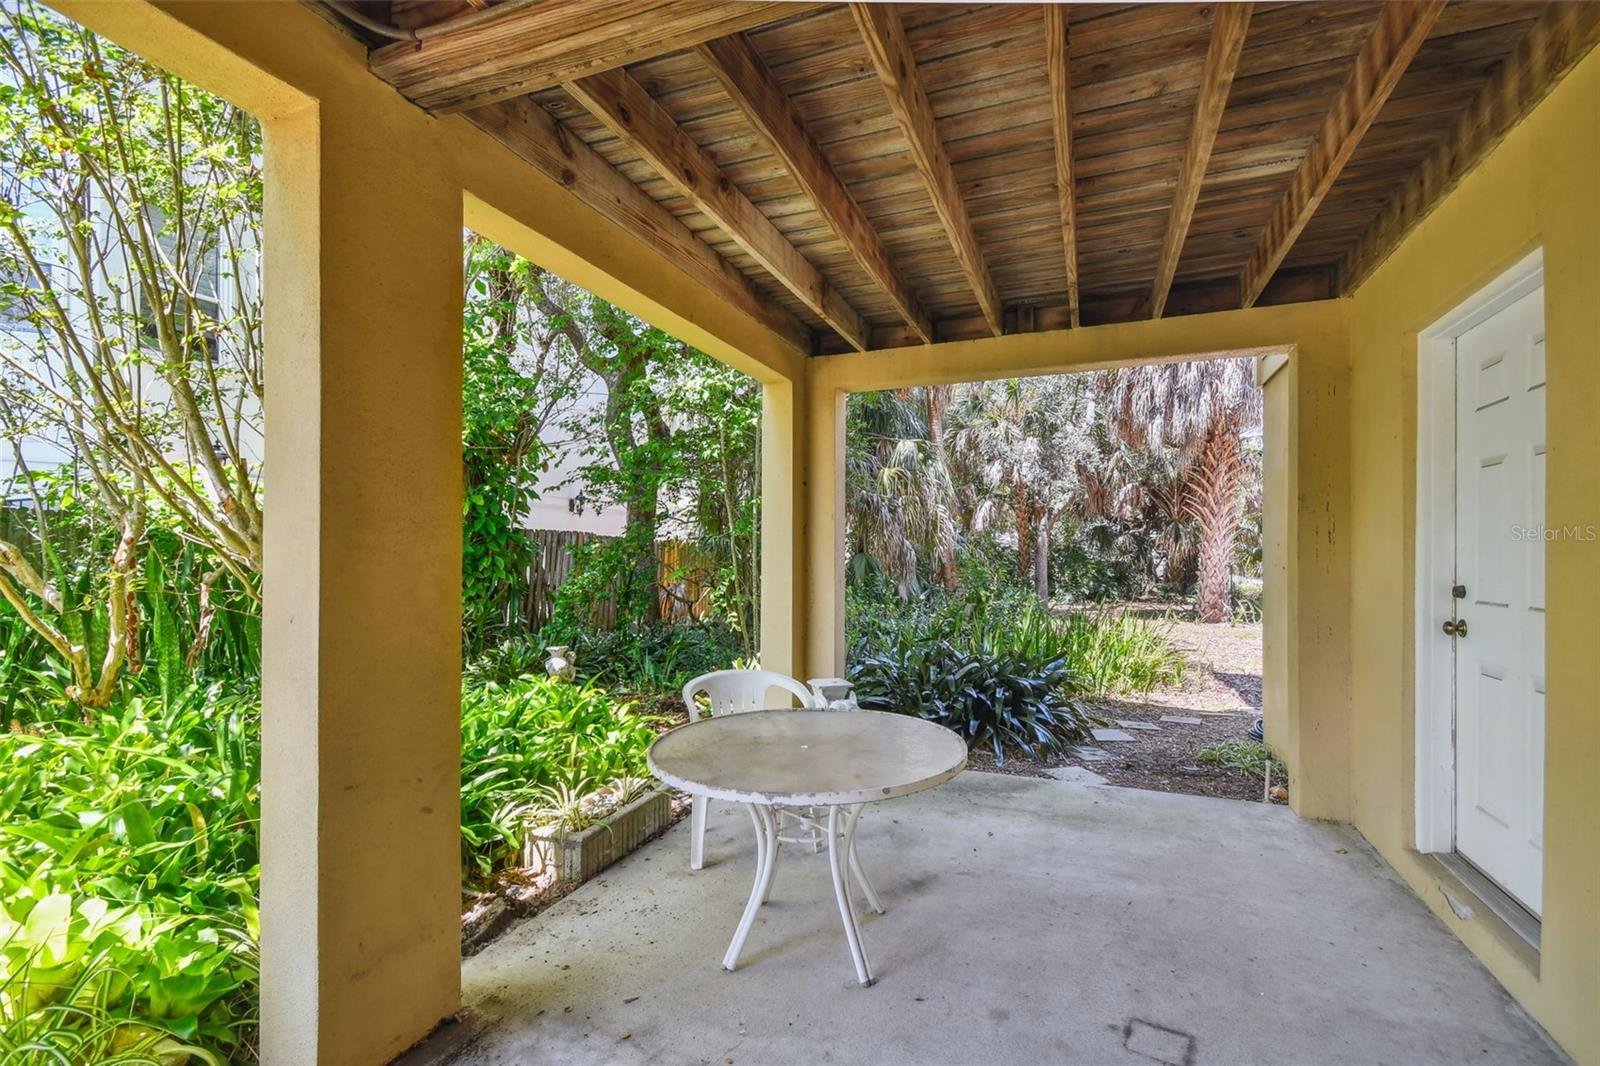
[1349,51,1600,1063]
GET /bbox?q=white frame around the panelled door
[1413,248,1544,853]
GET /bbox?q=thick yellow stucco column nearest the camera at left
[261,102,462,1063]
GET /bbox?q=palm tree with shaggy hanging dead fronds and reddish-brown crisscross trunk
[1102,359,1261,623]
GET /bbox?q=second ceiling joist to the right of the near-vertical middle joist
[1240,0,1445,307]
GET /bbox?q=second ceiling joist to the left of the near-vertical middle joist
[696,34,933,344]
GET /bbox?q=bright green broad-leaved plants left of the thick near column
[0,687,261,1061]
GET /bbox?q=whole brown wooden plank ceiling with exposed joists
[320,0,1600,352]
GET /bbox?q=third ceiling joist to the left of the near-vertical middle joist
[563,70,870,351]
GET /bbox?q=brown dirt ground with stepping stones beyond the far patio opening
[970,621,1283,802]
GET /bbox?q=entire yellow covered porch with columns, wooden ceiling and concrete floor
[51,0,1600,1066]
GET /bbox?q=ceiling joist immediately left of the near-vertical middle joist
[850,3,1005,336]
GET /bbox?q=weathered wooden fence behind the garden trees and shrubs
[501,530,717,632]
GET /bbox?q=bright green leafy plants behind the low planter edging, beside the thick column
[461,677,658,877]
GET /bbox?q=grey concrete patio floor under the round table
[402,773,1563,1066]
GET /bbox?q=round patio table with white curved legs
[650,711,966,986]
